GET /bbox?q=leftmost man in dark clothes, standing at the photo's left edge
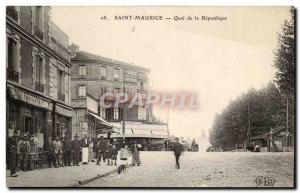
[8,130,19,177]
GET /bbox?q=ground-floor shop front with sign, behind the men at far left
[6,85,52,148]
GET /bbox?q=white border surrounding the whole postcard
[0,0,300,192]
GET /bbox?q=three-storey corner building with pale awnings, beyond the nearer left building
[71,49,168,143]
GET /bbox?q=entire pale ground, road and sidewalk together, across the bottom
[6,152,294,187]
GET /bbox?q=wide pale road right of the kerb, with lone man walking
[84,152,294,187]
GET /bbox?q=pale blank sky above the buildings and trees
[52,7,290,138]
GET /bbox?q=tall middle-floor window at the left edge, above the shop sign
[7,38,18,71]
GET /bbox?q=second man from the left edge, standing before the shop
[18,135,30,171]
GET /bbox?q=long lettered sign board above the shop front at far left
[9,87,52,110]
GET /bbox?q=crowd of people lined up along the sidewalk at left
[7,131,141,177]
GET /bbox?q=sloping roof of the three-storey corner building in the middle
[71,51,150,72]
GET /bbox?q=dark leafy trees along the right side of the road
[209,8,295,149]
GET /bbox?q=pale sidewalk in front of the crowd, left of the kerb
[6,162,117,187]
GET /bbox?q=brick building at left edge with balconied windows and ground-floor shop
[6,6,72,147]
